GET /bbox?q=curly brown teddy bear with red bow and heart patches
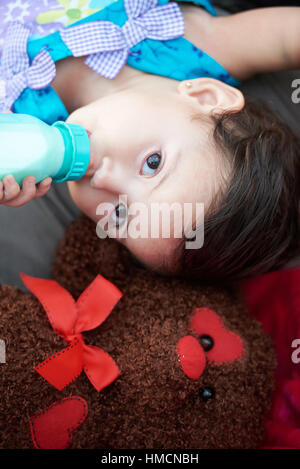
[0,215,275,449]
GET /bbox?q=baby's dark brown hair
[177,98,300,284]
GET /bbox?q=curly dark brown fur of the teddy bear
[0,216,275,449]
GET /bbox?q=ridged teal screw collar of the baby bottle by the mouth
[53,121,91,182]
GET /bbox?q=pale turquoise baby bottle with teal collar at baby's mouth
[0,113,90,185]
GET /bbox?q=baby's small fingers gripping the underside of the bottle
[0,176,52,207]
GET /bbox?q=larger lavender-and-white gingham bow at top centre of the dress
[60,0,184,78]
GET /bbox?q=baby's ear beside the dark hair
[177,78,245,114]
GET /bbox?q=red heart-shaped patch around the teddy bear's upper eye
[190,308,244,365]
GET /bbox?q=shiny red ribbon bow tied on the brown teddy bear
[20,273,122,391]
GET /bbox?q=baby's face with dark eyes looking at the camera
[67,84,221,269]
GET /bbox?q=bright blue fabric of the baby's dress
[12,0,239,124]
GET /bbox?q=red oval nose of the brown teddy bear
[177,335,206,379]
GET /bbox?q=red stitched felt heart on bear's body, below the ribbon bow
[30,396,88,449]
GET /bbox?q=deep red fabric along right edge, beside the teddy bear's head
[241,267,300,449]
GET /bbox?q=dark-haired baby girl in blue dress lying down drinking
[0,0,300,282]
